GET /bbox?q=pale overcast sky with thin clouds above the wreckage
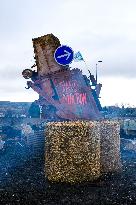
[0,0,136,106]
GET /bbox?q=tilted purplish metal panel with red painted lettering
[31,69,100,120]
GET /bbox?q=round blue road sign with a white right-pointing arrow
[54,45,74,65]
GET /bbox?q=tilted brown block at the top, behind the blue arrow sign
[32,34,62,77]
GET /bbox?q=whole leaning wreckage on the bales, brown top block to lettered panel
[22,34,102,121]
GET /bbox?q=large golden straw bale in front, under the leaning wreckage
[45,121,100,183]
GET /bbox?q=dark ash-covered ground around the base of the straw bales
[0,139,136,205]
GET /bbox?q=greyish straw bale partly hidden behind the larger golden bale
[98,120,121,173]
